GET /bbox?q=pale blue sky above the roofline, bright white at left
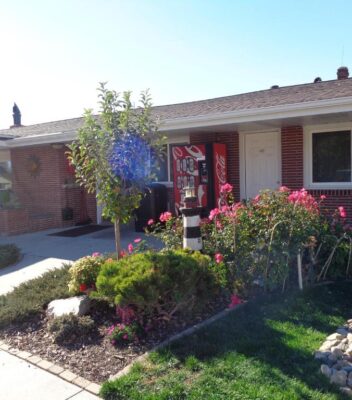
[0,0,352,128]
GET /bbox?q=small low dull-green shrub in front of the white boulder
[48,314,94,344]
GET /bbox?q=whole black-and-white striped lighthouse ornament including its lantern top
[180,187,203,250]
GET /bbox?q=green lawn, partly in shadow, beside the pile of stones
[101,282,352,400]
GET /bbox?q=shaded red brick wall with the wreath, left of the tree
[6,145,96,231]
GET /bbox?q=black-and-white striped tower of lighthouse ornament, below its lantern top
[181,202,203,250]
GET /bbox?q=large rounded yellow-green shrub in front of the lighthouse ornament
[97,250,218,319]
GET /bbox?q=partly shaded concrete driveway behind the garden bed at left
[0,226,160,295]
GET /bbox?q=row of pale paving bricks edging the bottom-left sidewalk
[0,340,101,395]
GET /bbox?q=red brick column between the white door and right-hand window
[281,126,303,189]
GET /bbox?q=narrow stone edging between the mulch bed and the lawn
[108,302,247,381]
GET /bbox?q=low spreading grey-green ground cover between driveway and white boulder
[0,265,69,329]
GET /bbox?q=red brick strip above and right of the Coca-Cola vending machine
[190,132,240,201]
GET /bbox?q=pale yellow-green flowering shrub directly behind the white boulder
[68,253,104,294]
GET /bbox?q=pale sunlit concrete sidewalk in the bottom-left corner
[0,350,99,400]
